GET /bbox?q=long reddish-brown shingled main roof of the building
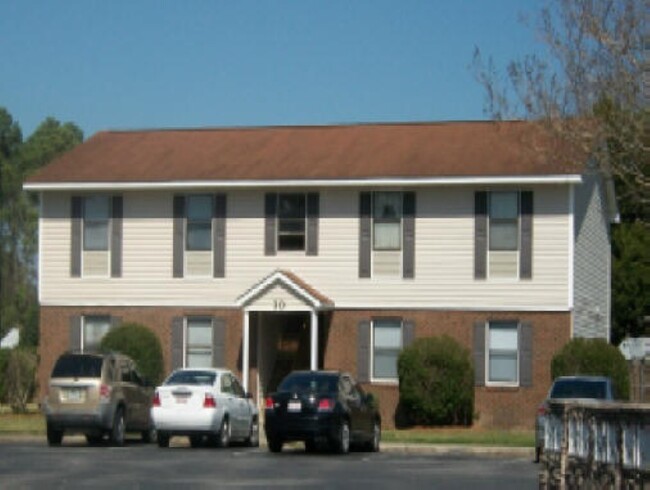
[27,121,576,184]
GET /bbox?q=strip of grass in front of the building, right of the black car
[382,427,535,447]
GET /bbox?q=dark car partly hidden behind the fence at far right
[535,376,616,461]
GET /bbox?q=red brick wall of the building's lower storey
[38,307,571,428]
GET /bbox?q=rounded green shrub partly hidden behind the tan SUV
[100,323,163,385]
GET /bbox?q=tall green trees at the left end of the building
[0,108,83,345]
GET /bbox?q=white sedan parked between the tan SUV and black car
[151,368,259,447]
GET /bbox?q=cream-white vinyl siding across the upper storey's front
[39,188,571,311]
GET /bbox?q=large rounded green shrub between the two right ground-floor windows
[397,335,474,425]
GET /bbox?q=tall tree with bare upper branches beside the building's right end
[474,0,650,342]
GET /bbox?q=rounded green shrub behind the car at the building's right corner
[551,339,630,400]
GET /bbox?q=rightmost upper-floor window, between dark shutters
[489,192,519,251]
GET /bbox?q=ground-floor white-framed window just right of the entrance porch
[372,318,402,381]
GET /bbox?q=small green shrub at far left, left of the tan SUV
[3,347,38,413]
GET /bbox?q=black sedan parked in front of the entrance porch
[264,371,381,454]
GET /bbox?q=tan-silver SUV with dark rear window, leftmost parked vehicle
[43,354,154,446]
